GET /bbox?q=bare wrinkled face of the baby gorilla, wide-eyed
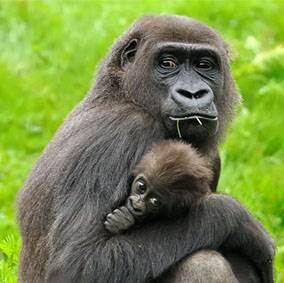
[127,175,163,216]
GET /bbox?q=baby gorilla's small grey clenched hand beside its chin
[104,206,135,234]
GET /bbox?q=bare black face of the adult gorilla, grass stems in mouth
[153,42,223,138]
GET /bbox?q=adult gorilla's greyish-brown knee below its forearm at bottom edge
[162,250,239,283]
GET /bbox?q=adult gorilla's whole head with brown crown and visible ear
[92,16,238,149]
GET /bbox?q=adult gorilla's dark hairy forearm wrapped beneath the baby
[48,192,274,282]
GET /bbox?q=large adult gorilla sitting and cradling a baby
[18,16,274,283]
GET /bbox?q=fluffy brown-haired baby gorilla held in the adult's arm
[104,141,213,234]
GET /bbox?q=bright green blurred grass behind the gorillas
[0,0,284,283]
